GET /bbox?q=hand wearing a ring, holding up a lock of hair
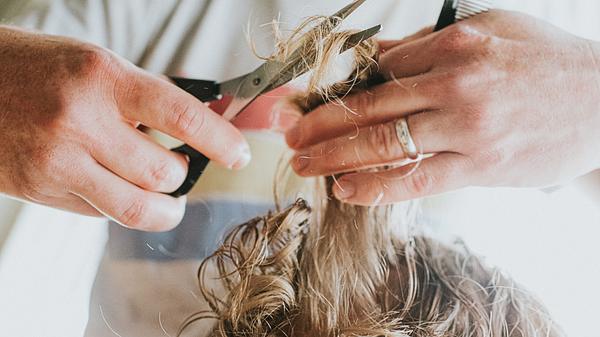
[287,11,600,205]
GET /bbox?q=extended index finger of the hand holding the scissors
[115,69,250,168]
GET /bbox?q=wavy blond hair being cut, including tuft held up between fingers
[180,18,562,337]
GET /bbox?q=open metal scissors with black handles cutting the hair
[165,0,381,197]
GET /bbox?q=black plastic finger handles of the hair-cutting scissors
[169,77,221,198]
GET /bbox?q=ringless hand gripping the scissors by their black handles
[0,27,250,231]
